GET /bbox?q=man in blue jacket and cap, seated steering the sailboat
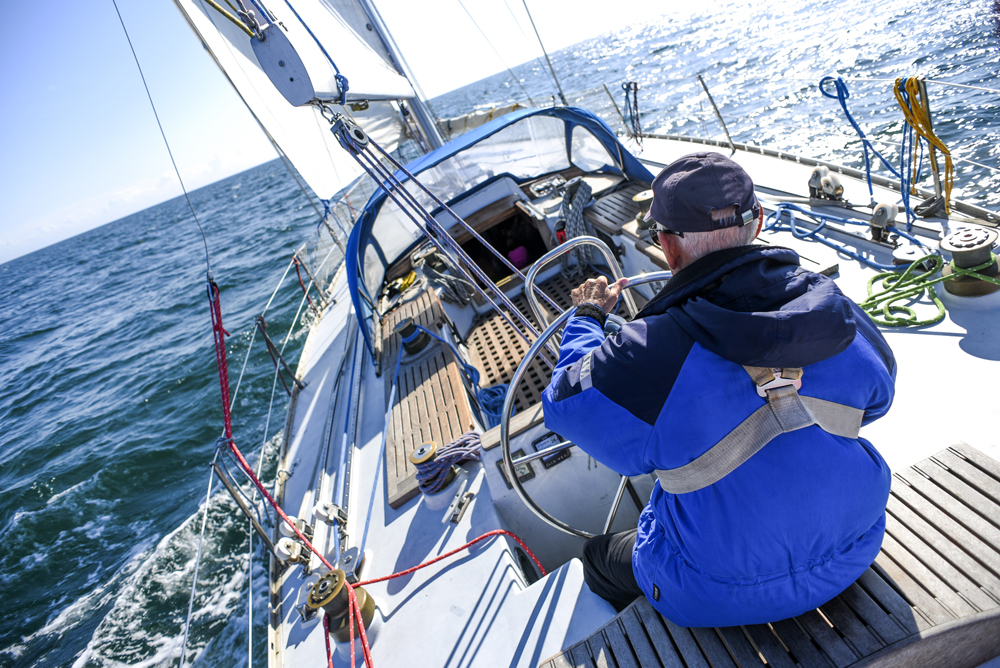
[543,153,895,626]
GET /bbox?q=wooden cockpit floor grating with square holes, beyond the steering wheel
[466,270,598,413]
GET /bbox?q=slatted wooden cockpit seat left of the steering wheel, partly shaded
[382,290,473,508]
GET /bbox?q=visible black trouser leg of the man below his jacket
[583,529,644,612]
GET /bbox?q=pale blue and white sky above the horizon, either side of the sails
[0,0,661,263]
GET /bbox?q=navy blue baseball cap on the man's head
[645,153,760,232]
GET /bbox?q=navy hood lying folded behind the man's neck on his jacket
[637,246,857,367]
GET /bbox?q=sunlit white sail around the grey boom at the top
[175,0,413,199]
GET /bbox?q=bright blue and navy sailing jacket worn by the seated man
[543,246,895,626]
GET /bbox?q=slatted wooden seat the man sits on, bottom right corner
[542,444,1000,668]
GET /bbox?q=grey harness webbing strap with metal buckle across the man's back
[654,367,865,494]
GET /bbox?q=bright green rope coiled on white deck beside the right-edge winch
[858,253,1000,327]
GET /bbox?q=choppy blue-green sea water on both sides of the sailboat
[0,0,1000,667]
